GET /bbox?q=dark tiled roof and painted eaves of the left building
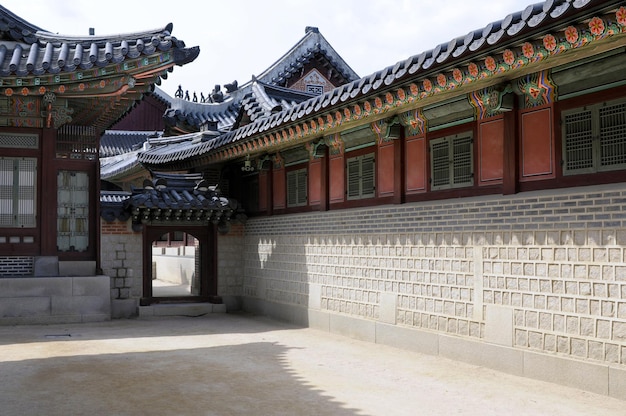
[0,6,200,131]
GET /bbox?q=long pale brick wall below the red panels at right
[243,184,626,364]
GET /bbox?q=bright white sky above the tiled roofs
[0,0,538,97]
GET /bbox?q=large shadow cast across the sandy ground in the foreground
[0,338,359,416]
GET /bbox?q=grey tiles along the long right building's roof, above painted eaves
[139,0,623,167]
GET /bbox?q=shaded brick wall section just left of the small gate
[100,220,143,299]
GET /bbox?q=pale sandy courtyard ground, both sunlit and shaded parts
[0,314,626,416]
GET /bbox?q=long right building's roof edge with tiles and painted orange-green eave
[139,0,626,168]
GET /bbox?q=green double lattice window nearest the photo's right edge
[562,100,626,175]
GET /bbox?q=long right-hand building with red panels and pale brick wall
[116,0,626,398]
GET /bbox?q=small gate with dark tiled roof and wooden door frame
[126,173,245,306]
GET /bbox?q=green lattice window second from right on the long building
[430,133,474,190]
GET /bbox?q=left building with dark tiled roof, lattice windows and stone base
[0,6,199,321]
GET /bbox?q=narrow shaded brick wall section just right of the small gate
[217,224,244,296]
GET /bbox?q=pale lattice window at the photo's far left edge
[0,157,37,228]
